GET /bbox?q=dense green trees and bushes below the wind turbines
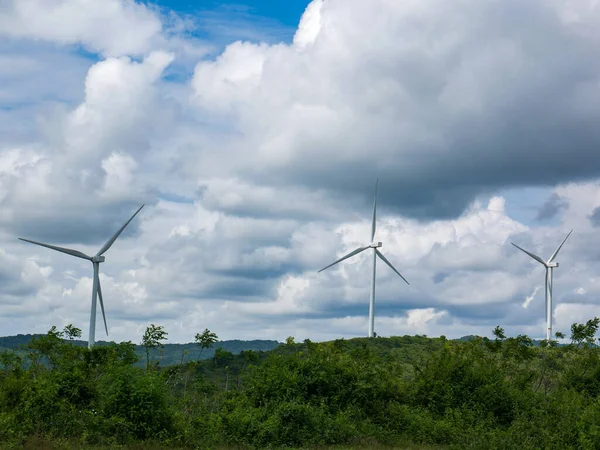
[0,318,600,449]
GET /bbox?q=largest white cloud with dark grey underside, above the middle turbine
[192,0,600,217]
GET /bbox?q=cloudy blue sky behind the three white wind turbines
[0,0,600,342]
